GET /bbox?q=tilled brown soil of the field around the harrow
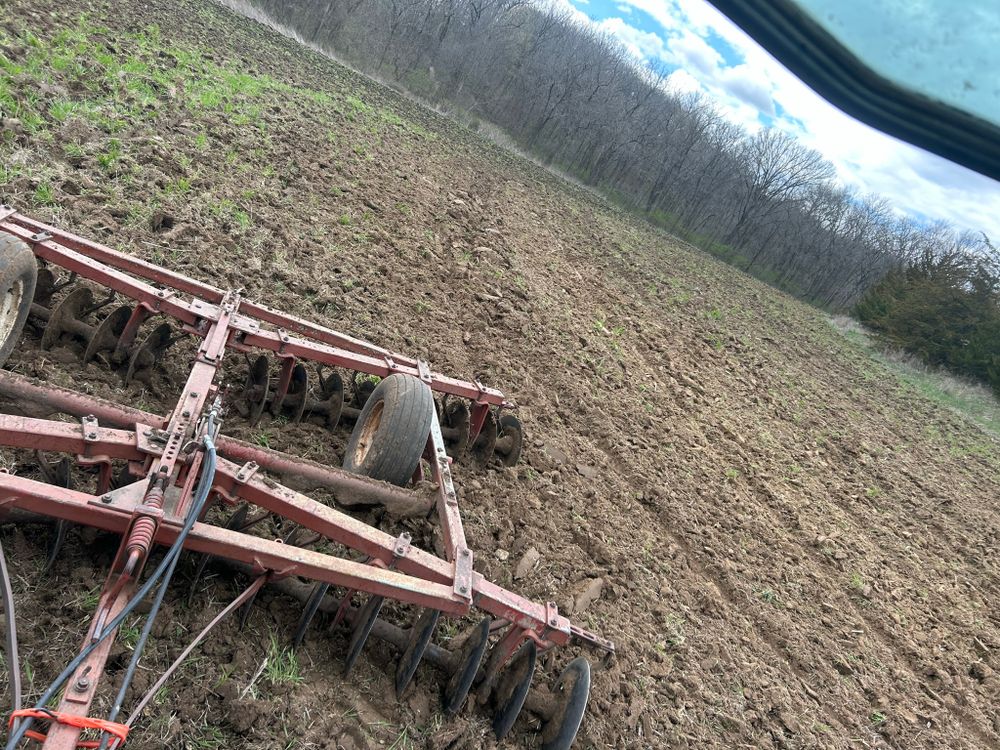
[0,0,1000,748]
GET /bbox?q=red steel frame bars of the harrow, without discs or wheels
[0,206,613,750]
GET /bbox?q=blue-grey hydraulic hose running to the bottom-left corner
[5,424,216,750]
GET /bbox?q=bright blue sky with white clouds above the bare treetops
[554,0,1000,243]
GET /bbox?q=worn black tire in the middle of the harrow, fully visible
[344,374,434,487]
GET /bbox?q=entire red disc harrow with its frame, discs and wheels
[0,206,614,750]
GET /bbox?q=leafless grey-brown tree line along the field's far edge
[236,0,996,388]
